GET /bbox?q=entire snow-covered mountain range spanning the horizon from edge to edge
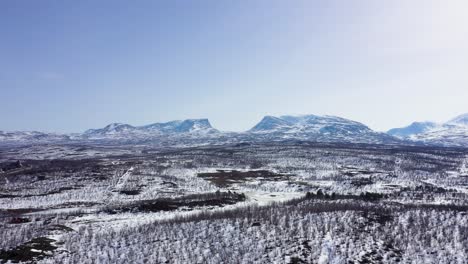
[0,114,468,147]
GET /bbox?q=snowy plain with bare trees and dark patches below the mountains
[0,142,468,263]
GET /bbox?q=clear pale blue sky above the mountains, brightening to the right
[0,0,468,132]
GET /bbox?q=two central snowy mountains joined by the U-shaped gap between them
[77,115,399,143]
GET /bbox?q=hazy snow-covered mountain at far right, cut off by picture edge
[387,114,468,147]
